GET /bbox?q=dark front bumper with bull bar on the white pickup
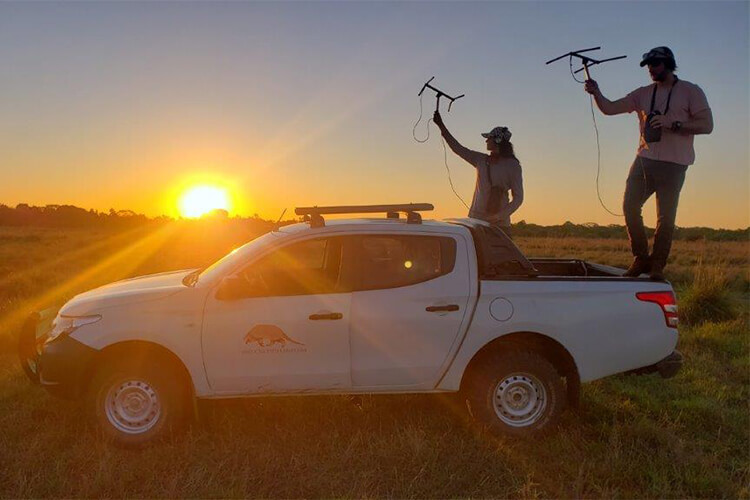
[18,313,97,399]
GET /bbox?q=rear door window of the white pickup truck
[357,235,456,290]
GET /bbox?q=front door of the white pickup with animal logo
[202,237,351,394]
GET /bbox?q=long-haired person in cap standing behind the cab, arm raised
[432,111,523,236]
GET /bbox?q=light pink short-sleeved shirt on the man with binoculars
[625,80,709,165]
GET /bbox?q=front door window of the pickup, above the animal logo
[241,238,343,296]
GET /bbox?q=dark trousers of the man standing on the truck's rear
[622,156,687,264]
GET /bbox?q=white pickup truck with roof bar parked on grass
[19,204,682,445]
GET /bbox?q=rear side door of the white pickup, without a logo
[350,234,470,390]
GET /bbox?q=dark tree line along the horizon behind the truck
[0,203,750,241]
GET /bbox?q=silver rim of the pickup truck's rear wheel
[492,373,547,427]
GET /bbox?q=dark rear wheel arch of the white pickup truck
[460,331,581,408]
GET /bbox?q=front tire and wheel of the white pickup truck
[88,359,190,448]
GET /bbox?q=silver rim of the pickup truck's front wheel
[104,380,161,434]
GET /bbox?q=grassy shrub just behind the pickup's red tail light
[679,260,737,325]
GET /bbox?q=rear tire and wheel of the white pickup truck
[466,350,565,437]
